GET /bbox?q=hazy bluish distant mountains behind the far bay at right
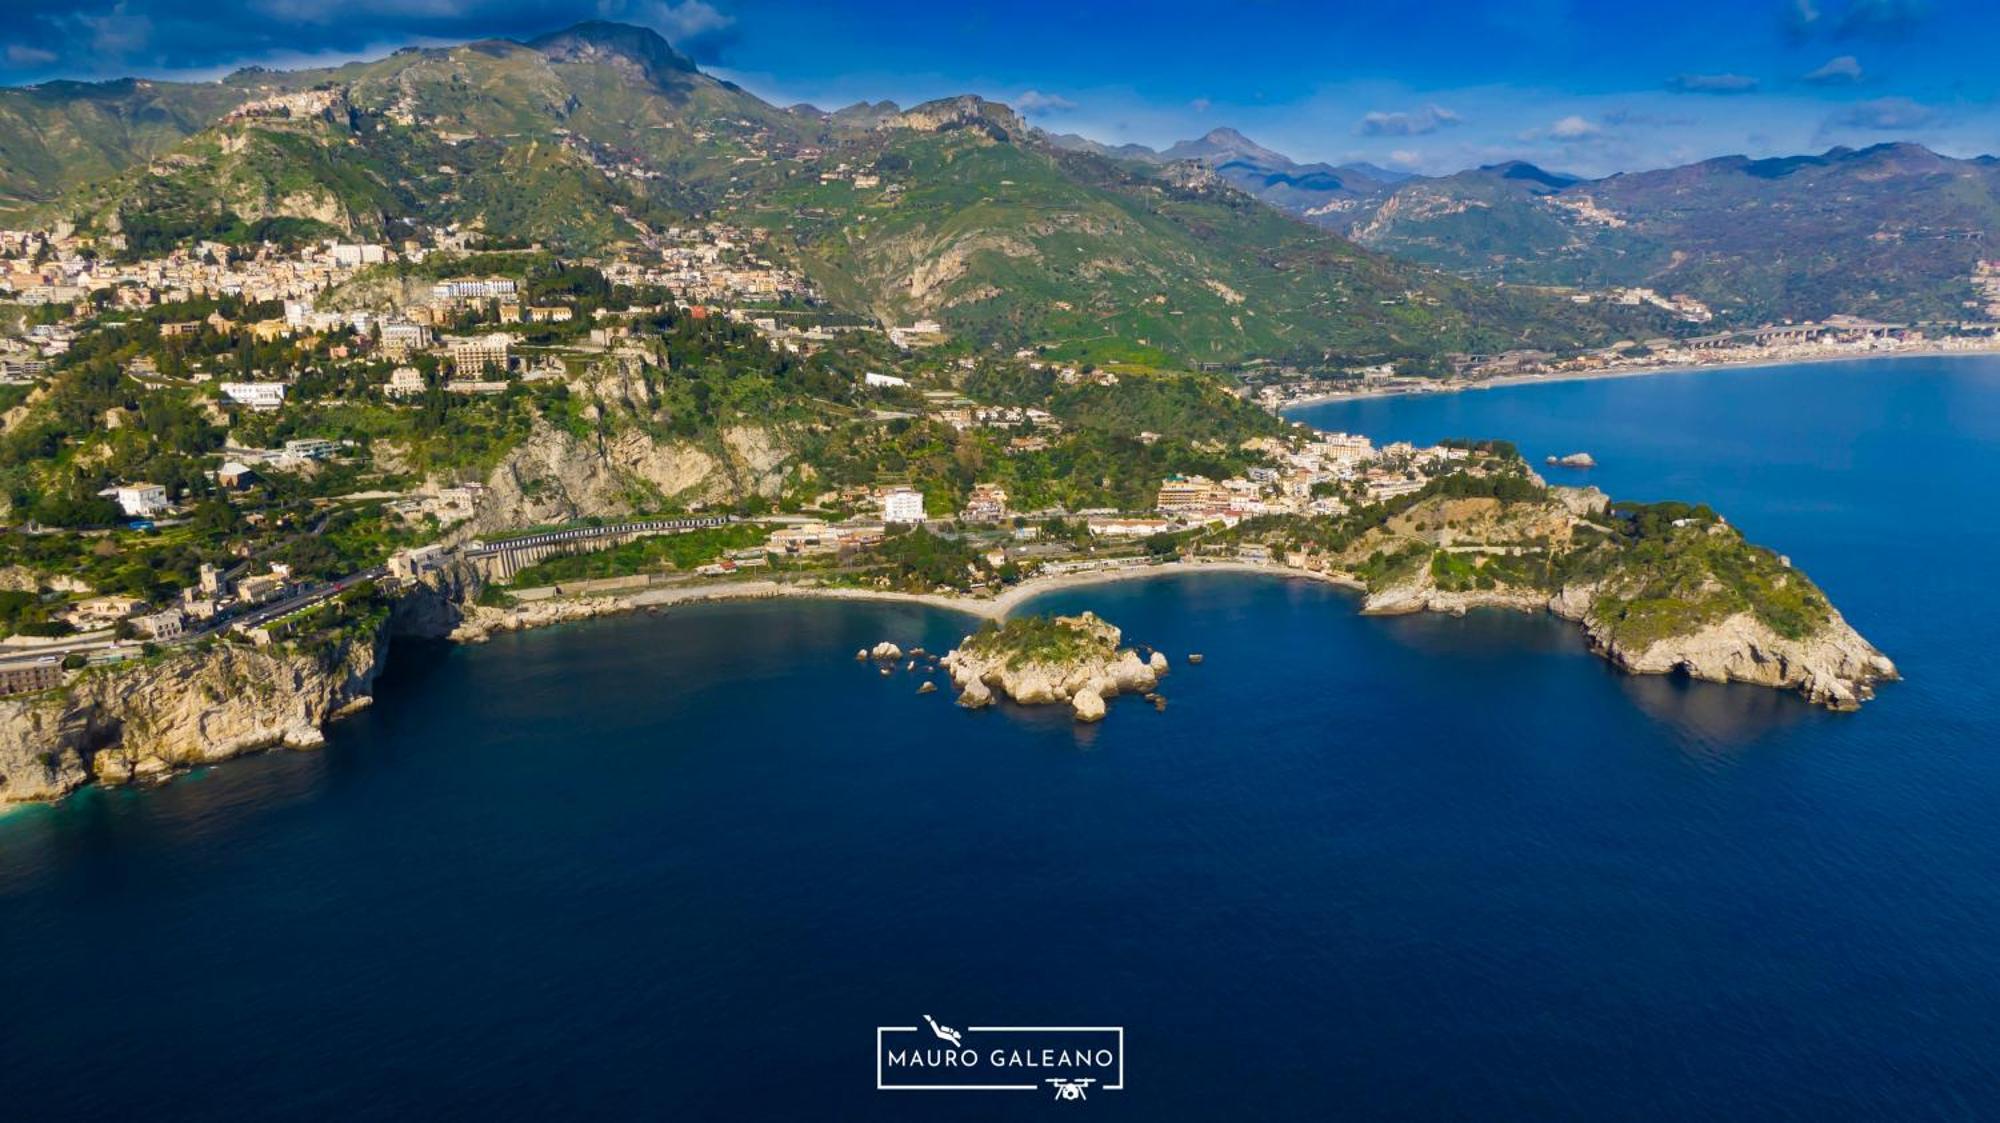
[1342,144,2000,322]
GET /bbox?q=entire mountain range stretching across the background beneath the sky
[0,22,2000,364]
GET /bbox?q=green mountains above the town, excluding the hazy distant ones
[23,22,1658,364]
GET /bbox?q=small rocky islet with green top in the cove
[942,611,1166,721]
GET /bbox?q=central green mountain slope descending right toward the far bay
[744,98,1640,362]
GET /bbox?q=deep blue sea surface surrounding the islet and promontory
[0,360,2000,1121]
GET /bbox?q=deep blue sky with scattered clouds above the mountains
[0,0,2000,174]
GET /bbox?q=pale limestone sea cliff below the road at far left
[0,623,386,801]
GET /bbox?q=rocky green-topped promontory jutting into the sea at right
[1266,456,1898,709]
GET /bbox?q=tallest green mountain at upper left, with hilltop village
[54,24,792,252]
